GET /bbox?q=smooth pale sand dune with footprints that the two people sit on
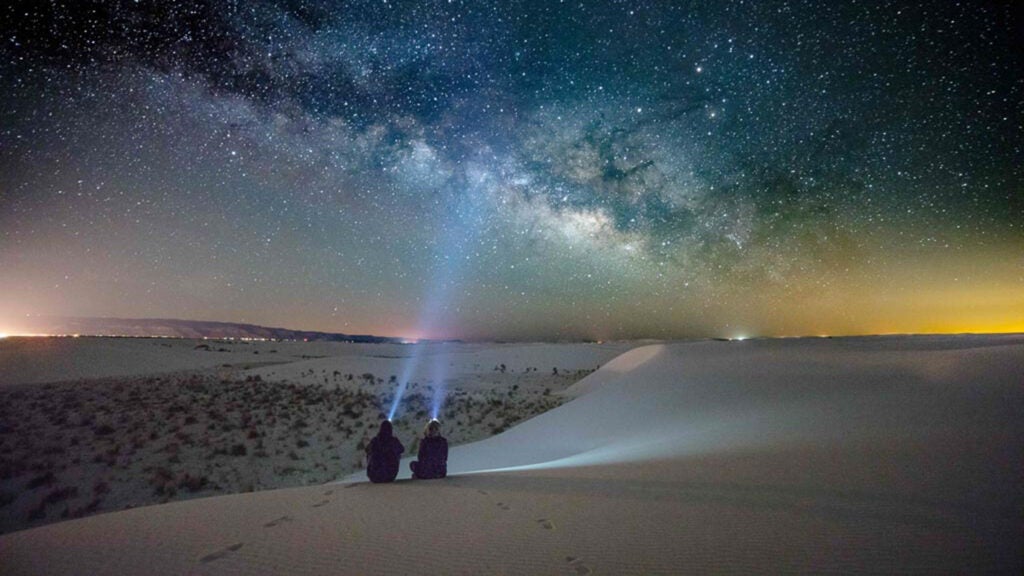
[0,336,1024,574]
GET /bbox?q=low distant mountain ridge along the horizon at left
[9,316,409,343]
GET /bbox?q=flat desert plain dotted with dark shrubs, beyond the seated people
[0,338,639,533]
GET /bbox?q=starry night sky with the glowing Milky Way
[0,0,1024,339]
